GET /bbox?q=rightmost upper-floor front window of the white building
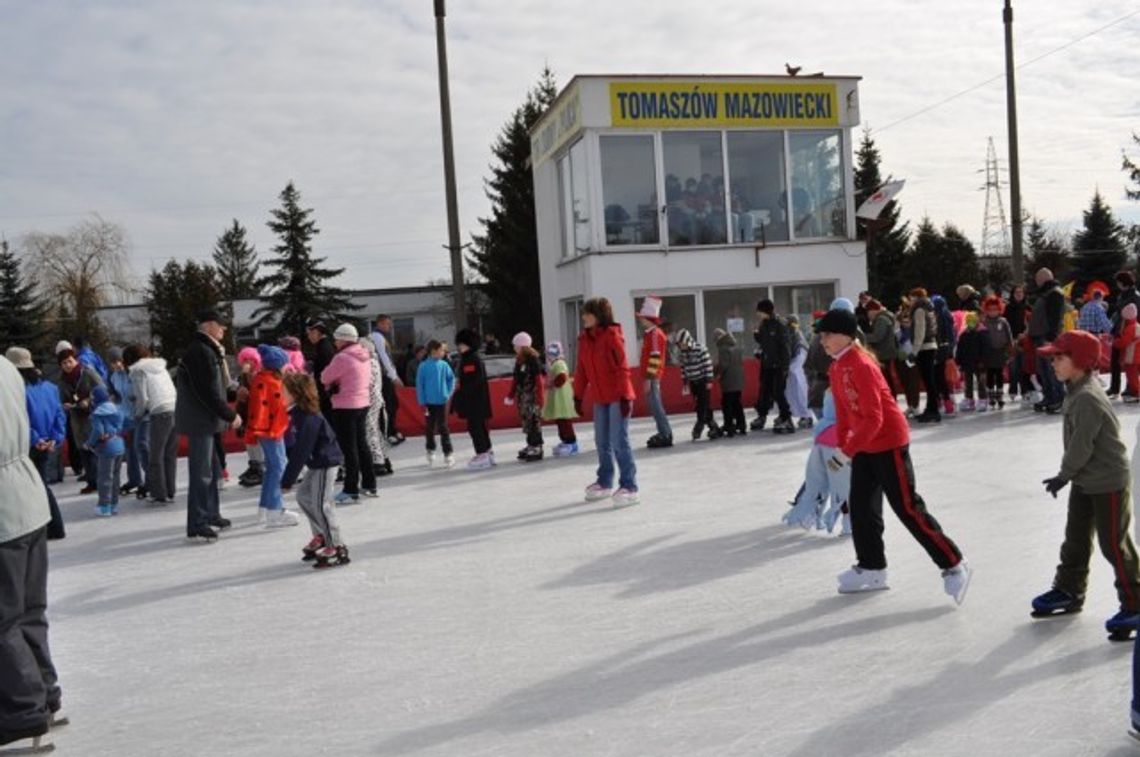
[788,131,847,239]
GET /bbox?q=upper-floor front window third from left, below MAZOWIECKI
[728,131,788,243]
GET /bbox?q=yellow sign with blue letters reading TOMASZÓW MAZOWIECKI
[610,81,839,129]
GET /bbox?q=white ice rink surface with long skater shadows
[40,408,1138,757]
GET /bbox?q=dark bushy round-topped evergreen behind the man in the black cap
[143,260,233,361]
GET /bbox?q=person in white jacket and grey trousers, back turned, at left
[123,344,178,504]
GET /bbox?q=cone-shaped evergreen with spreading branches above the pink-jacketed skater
[253,181,361,335]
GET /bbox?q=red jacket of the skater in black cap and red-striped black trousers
[828,345,911,457]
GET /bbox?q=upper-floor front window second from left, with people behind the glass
[661,131,727,246]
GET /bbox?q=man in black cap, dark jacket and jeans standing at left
[174,310,242,540]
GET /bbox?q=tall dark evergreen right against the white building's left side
[467,68,557,344]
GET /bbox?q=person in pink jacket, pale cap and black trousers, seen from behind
[320,324,380,504]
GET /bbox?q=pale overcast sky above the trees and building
[0,0,1140,296]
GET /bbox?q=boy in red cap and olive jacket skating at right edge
[1033,331,1140,640]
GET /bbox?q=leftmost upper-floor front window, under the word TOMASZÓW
[600,135,660,246]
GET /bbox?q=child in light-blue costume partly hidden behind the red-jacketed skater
[783,389,852,536]
